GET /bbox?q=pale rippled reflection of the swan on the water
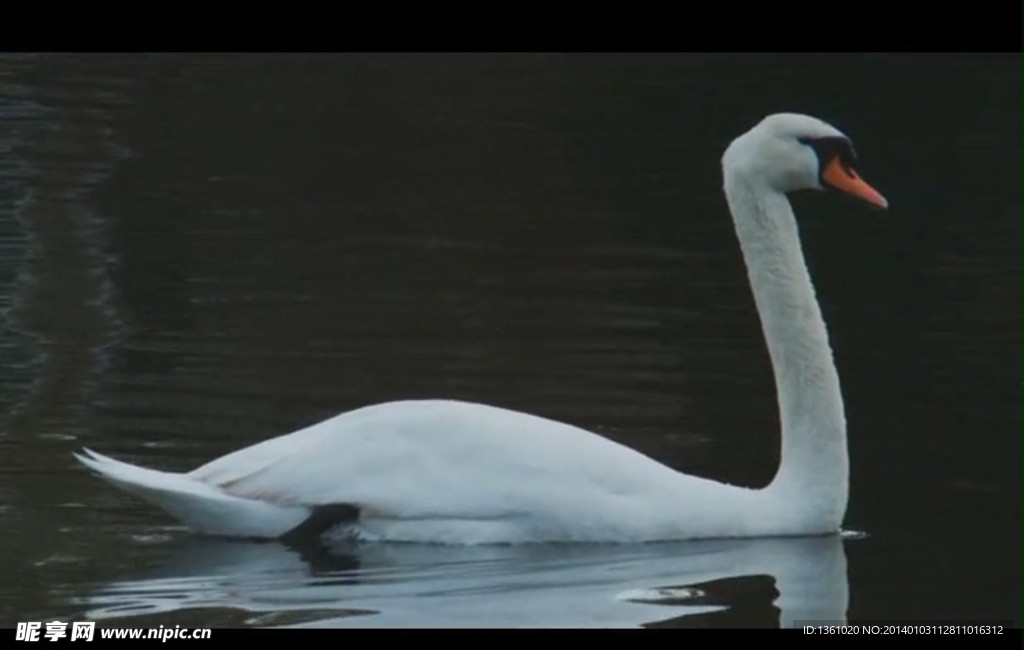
[80,535,849,627]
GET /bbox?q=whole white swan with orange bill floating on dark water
[75,113,888,545]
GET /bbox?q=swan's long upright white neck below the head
[725,174,849,532]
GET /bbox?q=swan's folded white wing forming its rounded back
[189,400,696,519]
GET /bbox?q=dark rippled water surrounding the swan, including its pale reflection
[0,54,1022,626]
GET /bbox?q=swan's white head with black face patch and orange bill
[722,113,889,208]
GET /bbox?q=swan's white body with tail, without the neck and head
[82,400,798,544]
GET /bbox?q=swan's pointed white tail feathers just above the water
[75,449,312,538]
